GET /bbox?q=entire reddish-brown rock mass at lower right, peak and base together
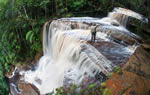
[106,47,150,95]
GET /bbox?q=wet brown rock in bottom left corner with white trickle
[9,68,40,95]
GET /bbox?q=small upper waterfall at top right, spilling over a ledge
[100,7,148,27]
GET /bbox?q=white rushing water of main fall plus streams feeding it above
[24,7,146,94]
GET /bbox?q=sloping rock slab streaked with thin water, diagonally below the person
[82,44,116,75]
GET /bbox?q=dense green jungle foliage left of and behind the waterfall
[0,0,150,95]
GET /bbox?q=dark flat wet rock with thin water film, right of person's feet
[89,41,130,65]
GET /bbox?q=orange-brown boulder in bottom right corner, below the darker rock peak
[106,71,150,95]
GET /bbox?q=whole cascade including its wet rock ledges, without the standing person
[20,9,147,94]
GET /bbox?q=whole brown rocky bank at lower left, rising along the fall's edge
[7,53,41,95]
